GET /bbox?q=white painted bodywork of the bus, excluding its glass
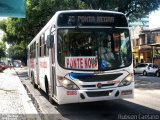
[28,10,134,104]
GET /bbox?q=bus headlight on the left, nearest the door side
[59,78,79,90]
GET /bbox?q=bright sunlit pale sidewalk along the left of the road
[0,68,40,120]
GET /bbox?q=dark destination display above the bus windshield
[58,12,128,27]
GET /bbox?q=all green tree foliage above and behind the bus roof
[0,0,160,61]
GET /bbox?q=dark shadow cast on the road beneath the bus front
[48,100,160,120]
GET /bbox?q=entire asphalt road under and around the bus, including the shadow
[16,68,160,120]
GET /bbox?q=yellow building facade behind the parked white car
[131,26,160,66]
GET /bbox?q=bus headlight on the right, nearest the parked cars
[118,74,133,87]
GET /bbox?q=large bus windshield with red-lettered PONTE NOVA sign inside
[57,28,132,70]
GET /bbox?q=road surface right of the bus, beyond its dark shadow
[126,75,160,111]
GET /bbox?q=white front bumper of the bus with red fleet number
[57,83,134,104]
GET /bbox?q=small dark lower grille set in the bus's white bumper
[86,90,113,97]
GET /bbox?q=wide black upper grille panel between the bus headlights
[79,73,123,82]
